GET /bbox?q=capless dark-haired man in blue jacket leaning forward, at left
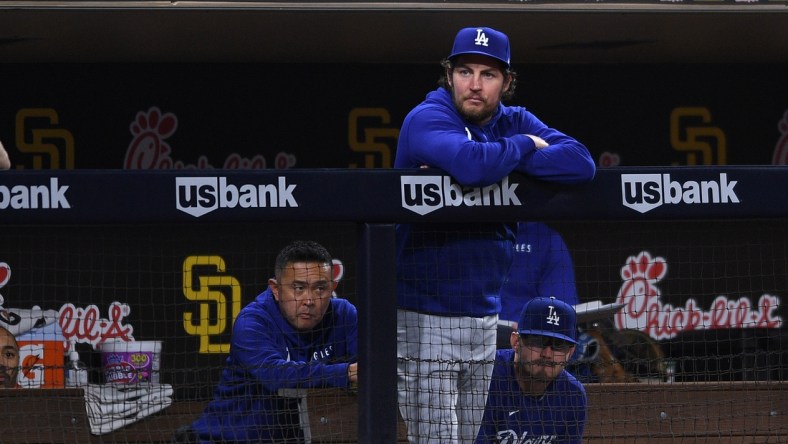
[175,241,358,443]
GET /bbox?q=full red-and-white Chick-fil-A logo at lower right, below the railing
[615,251,782,339]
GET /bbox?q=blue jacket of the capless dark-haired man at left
[192,289,358,443]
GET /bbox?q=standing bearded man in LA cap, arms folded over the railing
[394,27,595,443]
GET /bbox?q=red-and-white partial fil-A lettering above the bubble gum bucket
[58,302,134,348]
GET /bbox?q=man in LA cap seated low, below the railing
[476,297,587,444]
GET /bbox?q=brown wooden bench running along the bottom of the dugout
[0,382,788,444]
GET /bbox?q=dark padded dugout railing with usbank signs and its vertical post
[0,166,788,443]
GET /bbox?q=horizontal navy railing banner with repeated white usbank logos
[0,167,788,224]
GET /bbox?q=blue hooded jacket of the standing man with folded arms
[394,88,595,317]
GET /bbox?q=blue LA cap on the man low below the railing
[517,297,577,344]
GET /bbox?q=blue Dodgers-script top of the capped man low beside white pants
[476,349,588,444]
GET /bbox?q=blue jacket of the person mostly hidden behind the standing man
[500,222,578,322]
